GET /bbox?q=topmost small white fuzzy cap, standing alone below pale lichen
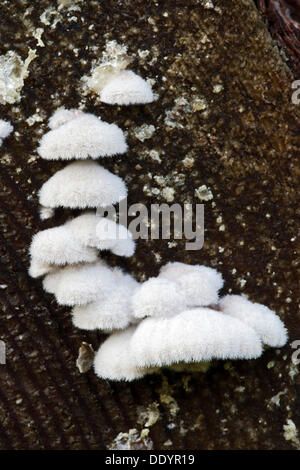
[100,70,154,105]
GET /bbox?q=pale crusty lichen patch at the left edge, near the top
[0,49,37,104]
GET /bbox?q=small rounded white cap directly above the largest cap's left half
[132,278,186,318]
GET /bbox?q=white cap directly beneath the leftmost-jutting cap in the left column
[43,261,118,307]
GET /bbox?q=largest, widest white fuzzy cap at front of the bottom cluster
[130,308,262,368]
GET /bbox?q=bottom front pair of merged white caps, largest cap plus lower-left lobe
[94,308,262,381]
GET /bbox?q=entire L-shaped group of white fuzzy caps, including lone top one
[29,66,287,380]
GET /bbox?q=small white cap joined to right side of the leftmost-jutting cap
[95,218,135,257]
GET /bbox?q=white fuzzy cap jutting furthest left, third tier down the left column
[30,224,98,265]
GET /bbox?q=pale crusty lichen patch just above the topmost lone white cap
[82,41,131,94]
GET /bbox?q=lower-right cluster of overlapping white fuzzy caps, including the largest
[95,262,287,381]
